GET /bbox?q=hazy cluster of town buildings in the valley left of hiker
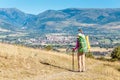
[25,33,76,45]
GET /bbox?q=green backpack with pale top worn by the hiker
[78,34,88,53]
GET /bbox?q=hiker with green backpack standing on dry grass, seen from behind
[73,29,87,72]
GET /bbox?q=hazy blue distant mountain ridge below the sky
[0,8,120,30]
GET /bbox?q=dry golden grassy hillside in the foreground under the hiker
[0,43,120,80]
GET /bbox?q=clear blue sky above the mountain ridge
[0,0,120,14]
